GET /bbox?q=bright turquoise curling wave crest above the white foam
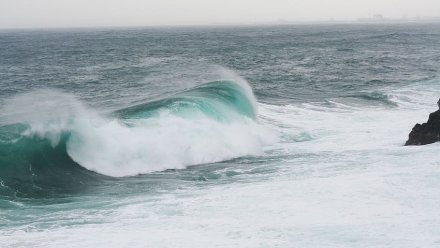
[116,81,256,122]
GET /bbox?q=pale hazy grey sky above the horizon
[0,0,440,28]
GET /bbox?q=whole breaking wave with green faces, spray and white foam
[0,78,276,197]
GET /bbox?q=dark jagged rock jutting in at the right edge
[405,99,440,146]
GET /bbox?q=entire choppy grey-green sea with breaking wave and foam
[0,24,440,248]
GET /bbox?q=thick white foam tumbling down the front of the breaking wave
[67,115,276,177]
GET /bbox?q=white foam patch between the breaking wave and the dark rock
[259,80,440,153]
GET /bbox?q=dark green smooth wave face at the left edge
[0,124,100,199]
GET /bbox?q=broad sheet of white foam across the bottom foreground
[0,154,440,248]
